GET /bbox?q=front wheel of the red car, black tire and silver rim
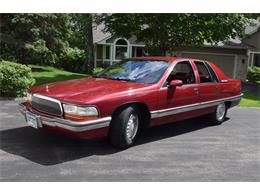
[109,106,141,149]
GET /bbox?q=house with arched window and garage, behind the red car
[93,23,260,81]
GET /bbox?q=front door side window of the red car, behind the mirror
[167,61,195,85]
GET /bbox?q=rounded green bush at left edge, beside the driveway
[0,61,35,97]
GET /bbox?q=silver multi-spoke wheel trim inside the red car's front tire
[126,114,139,141]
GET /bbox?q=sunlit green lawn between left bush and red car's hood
[29,65,89,85]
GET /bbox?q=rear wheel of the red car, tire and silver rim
[209,102,227,125]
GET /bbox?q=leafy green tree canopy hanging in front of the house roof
[98,13,259,55]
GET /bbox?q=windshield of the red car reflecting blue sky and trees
[97,60,170,84]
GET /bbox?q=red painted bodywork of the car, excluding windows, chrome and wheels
[26,57,241,139]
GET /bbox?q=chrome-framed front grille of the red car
[32,94,62,116]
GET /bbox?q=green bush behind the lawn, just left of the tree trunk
[59,48,86,72]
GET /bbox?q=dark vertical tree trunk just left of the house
[85,14,94,74]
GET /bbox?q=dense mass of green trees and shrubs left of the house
[0,14,93,72]
